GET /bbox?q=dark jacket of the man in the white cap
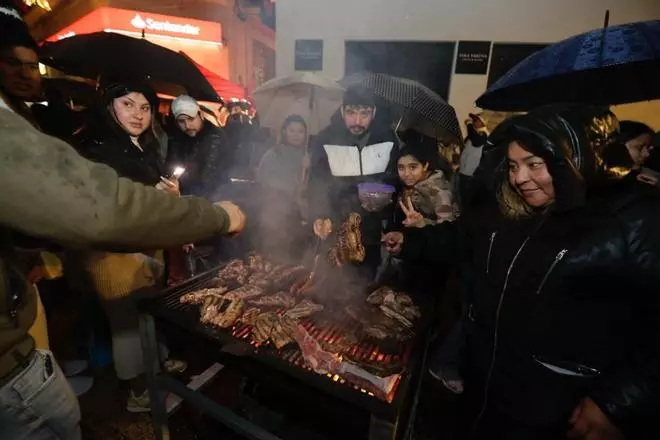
[167,121,233,196]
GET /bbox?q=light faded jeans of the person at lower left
[0,350,81,440]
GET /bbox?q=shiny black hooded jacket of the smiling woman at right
[402,105,660,439]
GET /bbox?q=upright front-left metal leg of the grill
[140,315,170,440]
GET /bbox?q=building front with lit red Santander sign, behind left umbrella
[25,0,275,95]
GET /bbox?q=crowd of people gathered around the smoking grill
[0,3,660,440]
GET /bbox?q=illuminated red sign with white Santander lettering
[46,7,222,46]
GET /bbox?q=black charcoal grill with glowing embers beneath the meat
[141,262,434,438]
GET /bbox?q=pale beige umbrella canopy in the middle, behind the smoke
[252,72,344,134]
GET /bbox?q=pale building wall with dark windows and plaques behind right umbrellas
[277,0,660,129]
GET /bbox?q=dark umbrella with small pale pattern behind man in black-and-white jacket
[339,72,462,144]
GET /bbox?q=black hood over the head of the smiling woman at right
[489,105,631,210]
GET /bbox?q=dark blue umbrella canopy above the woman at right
[477,20,660,111]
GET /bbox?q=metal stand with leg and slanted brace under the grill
[140,314,421,440]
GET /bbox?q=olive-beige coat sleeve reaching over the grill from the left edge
[0,109,229,251]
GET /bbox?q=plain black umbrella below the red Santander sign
[41,32,219,101]
